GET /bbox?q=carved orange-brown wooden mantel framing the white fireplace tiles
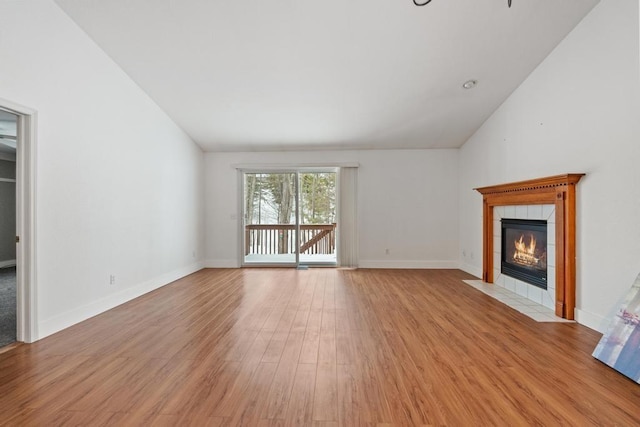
[475,173,585,320]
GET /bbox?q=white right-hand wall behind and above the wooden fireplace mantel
[460,0,640,331]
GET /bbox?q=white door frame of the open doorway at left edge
[0,98,38,343]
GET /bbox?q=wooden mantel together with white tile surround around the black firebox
[475,174,584,320]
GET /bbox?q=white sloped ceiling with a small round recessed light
[56,0,598,151]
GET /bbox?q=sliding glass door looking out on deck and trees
[242,169,338,266]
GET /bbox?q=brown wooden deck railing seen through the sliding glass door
[244,224,336,255]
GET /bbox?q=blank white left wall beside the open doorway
[0,0,204,337]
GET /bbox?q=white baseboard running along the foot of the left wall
[34,262,203,341]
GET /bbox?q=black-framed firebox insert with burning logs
[501,218,547,290]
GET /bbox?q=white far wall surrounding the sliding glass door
[205,150,458,268]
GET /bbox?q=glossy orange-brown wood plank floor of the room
[0,269,640,426]
